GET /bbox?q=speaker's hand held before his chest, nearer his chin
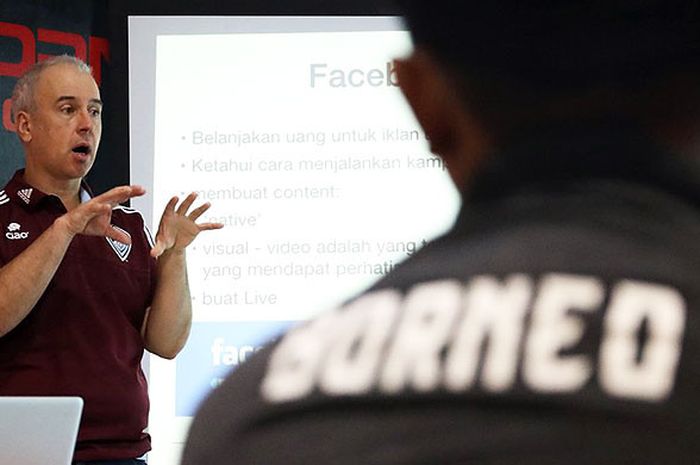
[60,186,146,244]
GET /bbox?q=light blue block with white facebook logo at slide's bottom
[175,321,297,416]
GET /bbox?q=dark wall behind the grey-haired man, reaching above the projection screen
[0,0,397,193]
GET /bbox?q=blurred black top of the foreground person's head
[398,0,700,134]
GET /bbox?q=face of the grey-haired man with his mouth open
[25,64,102,181]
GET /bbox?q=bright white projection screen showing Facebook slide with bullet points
[130,17,459,465]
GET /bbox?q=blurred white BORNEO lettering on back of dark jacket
[261,273,686,402]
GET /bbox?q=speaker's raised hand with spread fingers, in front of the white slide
[151,192,224,257]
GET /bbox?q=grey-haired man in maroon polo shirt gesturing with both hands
[0,56,222,464]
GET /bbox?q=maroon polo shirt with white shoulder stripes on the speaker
[0,170,156,460]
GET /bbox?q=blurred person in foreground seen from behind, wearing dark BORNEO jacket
[183,0,700,465]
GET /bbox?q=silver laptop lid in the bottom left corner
[0,396,83,465]
